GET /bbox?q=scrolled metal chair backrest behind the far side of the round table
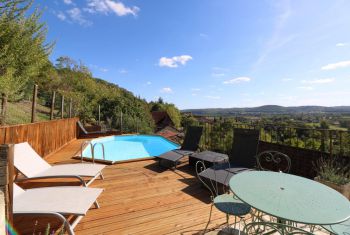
[256,150,291,173]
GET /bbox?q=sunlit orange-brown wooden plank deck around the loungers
[14,140,232,234]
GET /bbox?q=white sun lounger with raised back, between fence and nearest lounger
[14,142,105,186]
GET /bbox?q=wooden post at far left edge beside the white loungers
[0,145,14,234]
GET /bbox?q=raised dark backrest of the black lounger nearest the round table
[229,128,260,168]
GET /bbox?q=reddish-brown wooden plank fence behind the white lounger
[0,118,79,157]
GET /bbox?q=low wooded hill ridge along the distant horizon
[181,105,350,116]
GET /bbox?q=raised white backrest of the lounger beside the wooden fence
[14,142,51,178]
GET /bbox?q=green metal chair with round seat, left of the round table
[196,161,251,234]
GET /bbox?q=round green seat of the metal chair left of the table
[214,194,251,216]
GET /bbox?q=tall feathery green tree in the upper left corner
[0,0,53,124]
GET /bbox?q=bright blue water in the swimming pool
[83,135,179,163]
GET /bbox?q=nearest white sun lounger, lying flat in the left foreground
[13,184,103,235]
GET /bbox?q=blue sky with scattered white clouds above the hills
[35,0,350,109]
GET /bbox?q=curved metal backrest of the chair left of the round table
[196,157,232,199]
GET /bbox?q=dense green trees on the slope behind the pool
[44,56,153,133]
